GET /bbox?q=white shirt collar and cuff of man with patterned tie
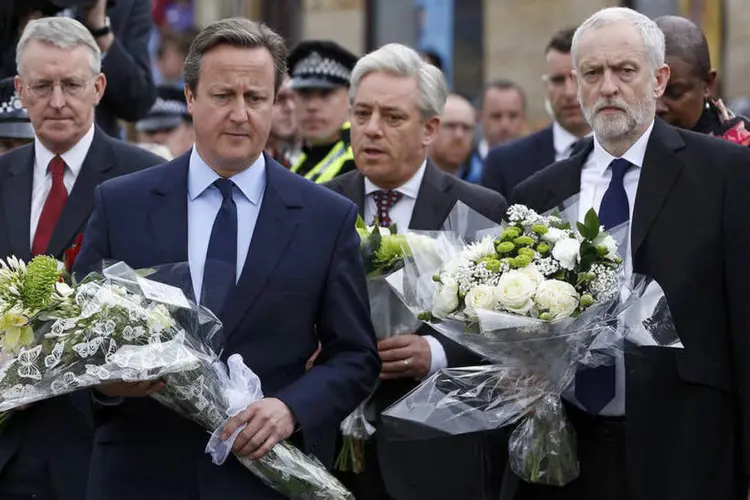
[364,160,448,375]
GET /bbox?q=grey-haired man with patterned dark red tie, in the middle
[327,44,507,500]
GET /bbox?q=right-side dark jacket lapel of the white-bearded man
[631,119,685,255]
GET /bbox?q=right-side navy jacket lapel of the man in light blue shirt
[221,155,302,340]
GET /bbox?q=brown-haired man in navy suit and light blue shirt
[76,18,380,500]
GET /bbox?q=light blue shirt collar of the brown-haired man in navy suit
[188,147,266,206]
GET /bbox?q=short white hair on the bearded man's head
[571,7,665,70]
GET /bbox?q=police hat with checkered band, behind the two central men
[288,40,358,90]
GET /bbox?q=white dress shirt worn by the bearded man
[565,122,654,416]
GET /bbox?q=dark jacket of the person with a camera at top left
[96,0,156,138]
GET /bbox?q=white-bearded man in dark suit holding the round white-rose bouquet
[506,4,750,500]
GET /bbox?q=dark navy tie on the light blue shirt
[201,179,237,315]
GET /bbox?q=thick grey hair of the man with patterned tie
[349,43,448,120]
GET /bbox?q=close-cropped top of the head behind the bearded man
[656,16,711,80]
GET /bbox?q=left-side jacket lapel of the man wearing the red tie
[2,145,34,260]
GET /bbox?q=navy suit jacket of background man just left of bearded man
[481,125,555,198]
